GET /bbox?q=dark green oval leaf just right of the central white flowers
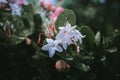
[81,26,95,51]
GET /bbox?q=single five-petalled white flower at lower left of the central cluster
[42,38,63,57]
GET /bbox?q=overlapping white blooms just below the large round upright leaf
[55,23,85,50]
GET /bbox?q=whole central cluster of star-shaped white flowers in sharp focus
[41,23,84,57]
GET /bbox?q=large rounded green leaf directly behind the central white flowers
[55,9,76,28]
